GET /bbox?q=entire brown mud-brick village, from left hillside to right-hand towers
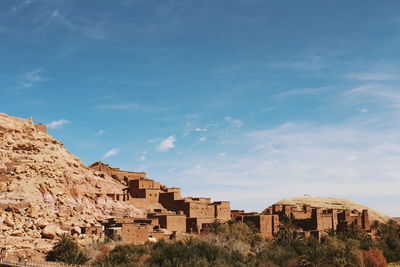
[82,162,370,243]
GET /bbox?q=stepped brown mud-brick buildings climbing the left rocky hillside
[86,162,231,243]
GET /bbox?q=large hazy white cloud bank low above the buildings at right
[170,122,400,217]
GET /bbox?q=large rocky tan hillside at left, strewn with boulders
[0,114,143,260]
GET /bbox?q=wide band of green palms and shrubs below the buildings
[49,219,400,267]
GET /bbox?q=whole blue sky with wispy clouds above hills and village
[0,0,400,216]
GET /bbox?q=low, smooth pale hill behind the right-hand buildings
[270,196,390,222]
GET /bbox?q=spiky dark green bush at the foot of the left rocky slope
[46,234,90,264]
